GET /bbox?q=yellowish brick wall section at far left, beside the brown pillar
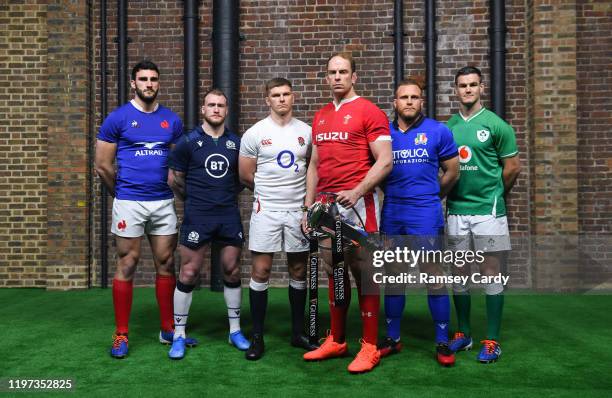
[0,2,48,287]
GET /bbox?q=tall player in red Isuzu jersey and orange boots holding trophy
[303,52,392,373]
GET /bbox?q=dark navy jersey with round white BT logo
[170,126,241,224]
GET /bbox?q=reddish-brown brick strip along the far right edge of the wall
[576,0,612,289]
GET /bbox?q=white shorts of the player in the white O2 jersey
[249,209,310,253]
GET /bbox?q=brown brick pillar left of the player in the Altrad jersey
[47,1,93,289]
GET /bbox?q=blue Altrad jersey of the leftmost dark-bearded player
[97,102,183,201]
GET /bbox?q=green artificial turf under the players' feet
[0,288,612,398]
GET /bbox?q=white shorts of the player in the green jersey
[446,214,511,253]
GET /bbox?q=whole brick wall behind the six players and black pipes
[0,0,612,286]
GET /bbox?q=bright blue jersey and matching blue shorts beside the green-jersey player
[382,117,458,231]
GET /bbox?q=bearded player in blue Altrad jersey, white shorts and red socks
[95,60,196,358]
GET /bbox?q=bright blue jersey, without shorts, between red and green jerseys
[385,117,458,206]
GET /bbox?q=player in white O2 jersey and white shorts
[240,78,316,360]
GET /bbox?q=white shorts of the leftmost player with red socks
[111,199,178,238]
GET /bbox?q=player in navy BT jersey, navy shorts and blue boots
[168,88,249,359]
